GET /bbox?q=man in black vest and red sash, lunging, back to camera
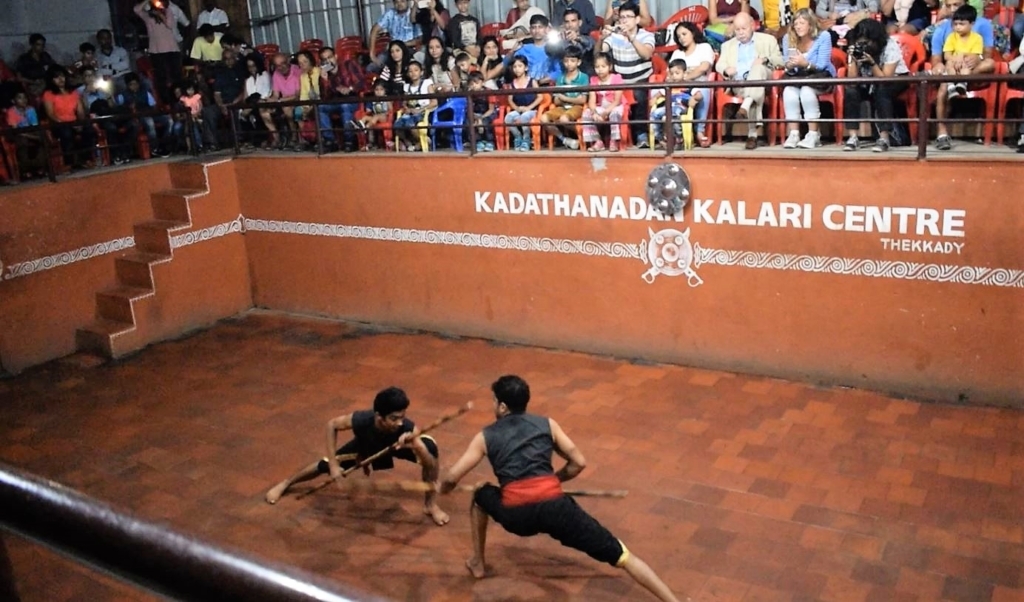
[439,376,678,602]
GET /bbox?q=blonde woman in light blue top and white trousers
[782,8,836,148]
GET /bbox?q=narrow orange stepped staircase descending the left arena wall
[76,163,209,358]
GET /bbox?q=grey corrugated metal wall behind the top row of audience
[249,0,761,49]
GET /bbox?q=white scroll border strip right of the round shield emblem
[693,244,1024,288]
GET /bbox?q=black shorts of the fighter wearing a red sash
[473,484,629,567]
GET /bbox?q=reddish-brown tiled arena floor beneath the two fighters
[0,313,1024,602]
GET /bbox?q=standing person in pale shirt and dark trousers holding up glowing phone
[134,0,189,104]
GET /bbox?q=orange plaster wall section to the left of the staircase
[0,165,171,372]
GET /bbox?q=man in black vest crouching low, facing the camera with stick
[265,387,449,526]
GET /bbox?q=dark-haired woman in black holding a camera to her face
[843,19,910,153]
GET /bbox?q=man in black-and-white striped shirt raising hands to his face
[594,2,655,148]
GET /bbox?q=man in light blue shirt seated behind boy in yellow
[931,0,995,151]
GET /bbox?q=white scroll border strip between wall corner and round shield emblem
[245,218,643,260]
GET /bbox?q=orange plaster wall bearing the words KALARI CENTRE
[236,157,1024,404]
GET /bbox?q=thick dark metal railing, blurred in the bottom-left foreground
[0,463,382,602]
